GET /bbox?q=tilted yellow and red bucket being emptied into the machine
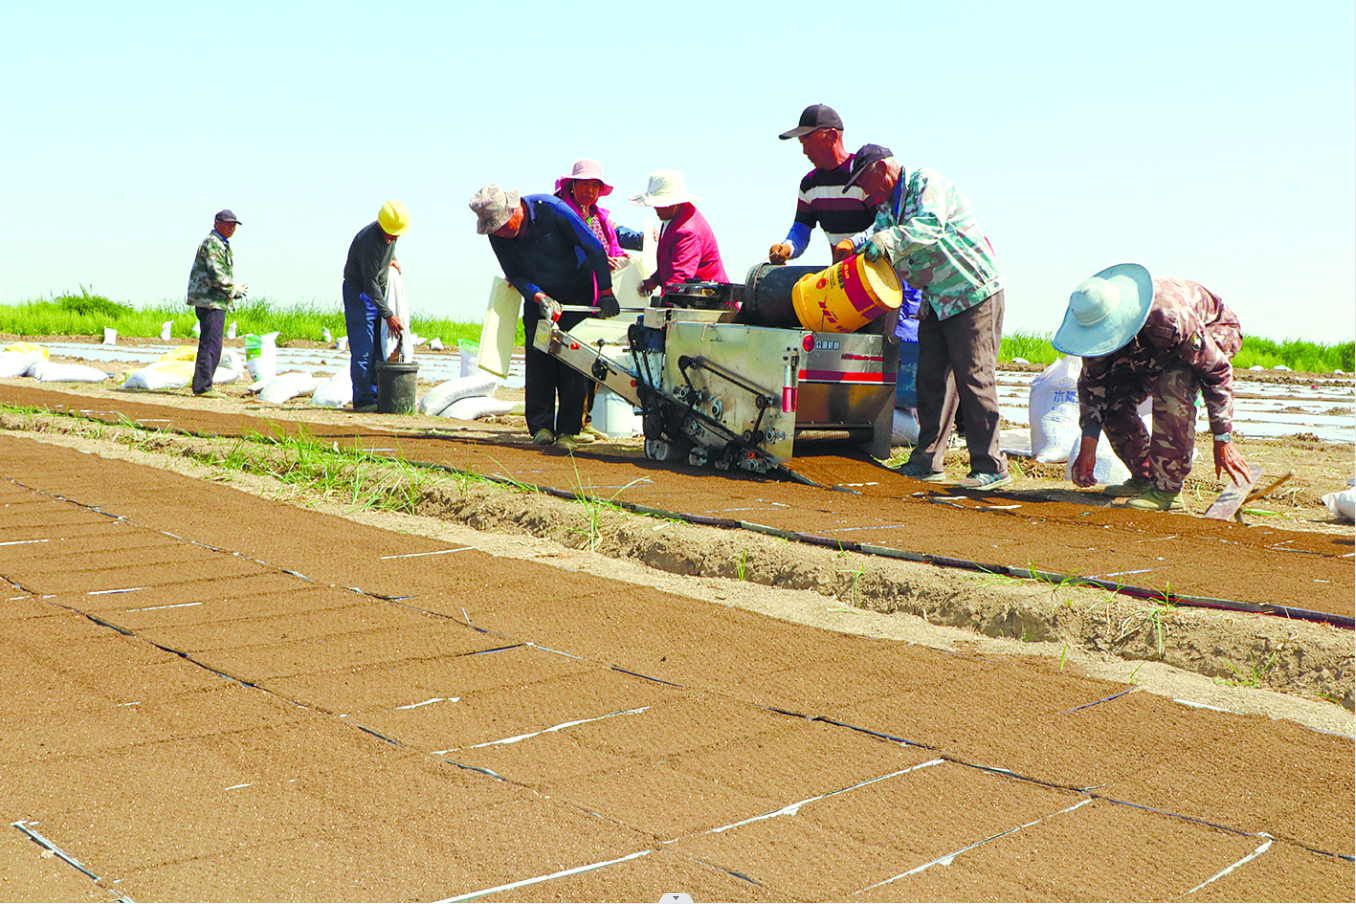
[791,255,903,332]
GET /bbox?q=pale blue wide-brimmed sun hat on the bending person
[1051,264,1154,358]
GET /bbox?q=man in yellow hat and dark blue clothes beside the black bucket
[343,201,410,412]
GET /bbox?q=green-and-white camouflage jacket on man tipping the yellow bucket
[853,167,1003,320]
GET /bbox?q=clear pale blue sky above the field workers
[0,0,1356,343]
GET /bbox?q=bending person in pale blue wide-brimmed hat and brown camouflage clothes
[1054,264,1250,511]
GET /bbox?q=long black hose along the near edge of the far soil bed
[405,459,1356,628]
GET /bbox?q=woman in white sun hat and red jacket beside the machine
[631,169,730,295]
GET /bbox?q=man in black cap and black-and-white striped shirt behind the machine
[767,103,875,264]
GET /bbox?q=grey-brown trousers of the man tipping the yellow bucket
[909,291,1008,474]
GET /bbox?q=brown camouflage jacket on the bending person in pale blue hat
[1078,278,1243,435]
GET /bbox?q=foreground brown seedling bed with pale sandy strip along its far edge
[0,431,1353,900]
